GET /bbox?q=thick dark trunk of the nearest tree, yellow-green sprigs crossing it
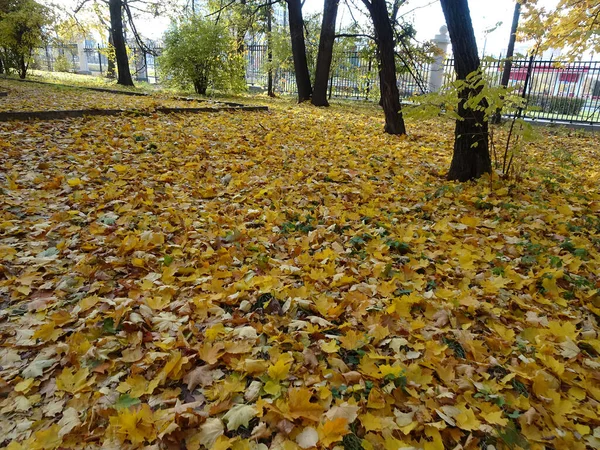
[441,0,492,181]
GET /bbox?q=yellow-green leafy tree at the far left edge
[0,0,52,78]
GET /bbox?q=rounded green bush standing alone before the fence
[158,16,246,95]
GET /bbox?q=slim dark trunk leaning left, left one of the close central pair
[287,0,312,103]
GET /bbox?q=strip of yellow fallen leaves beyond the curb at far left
[0,79,225,112]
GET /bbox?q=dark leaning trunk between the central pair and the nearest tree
[363,0,406,134]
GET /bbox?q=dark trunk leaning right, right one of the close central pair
[312,0,339,106]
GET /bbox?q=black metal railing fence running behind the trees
[34,44,600,123]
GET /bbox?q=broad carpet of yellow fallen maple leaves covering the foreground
[0,84,600,450]
